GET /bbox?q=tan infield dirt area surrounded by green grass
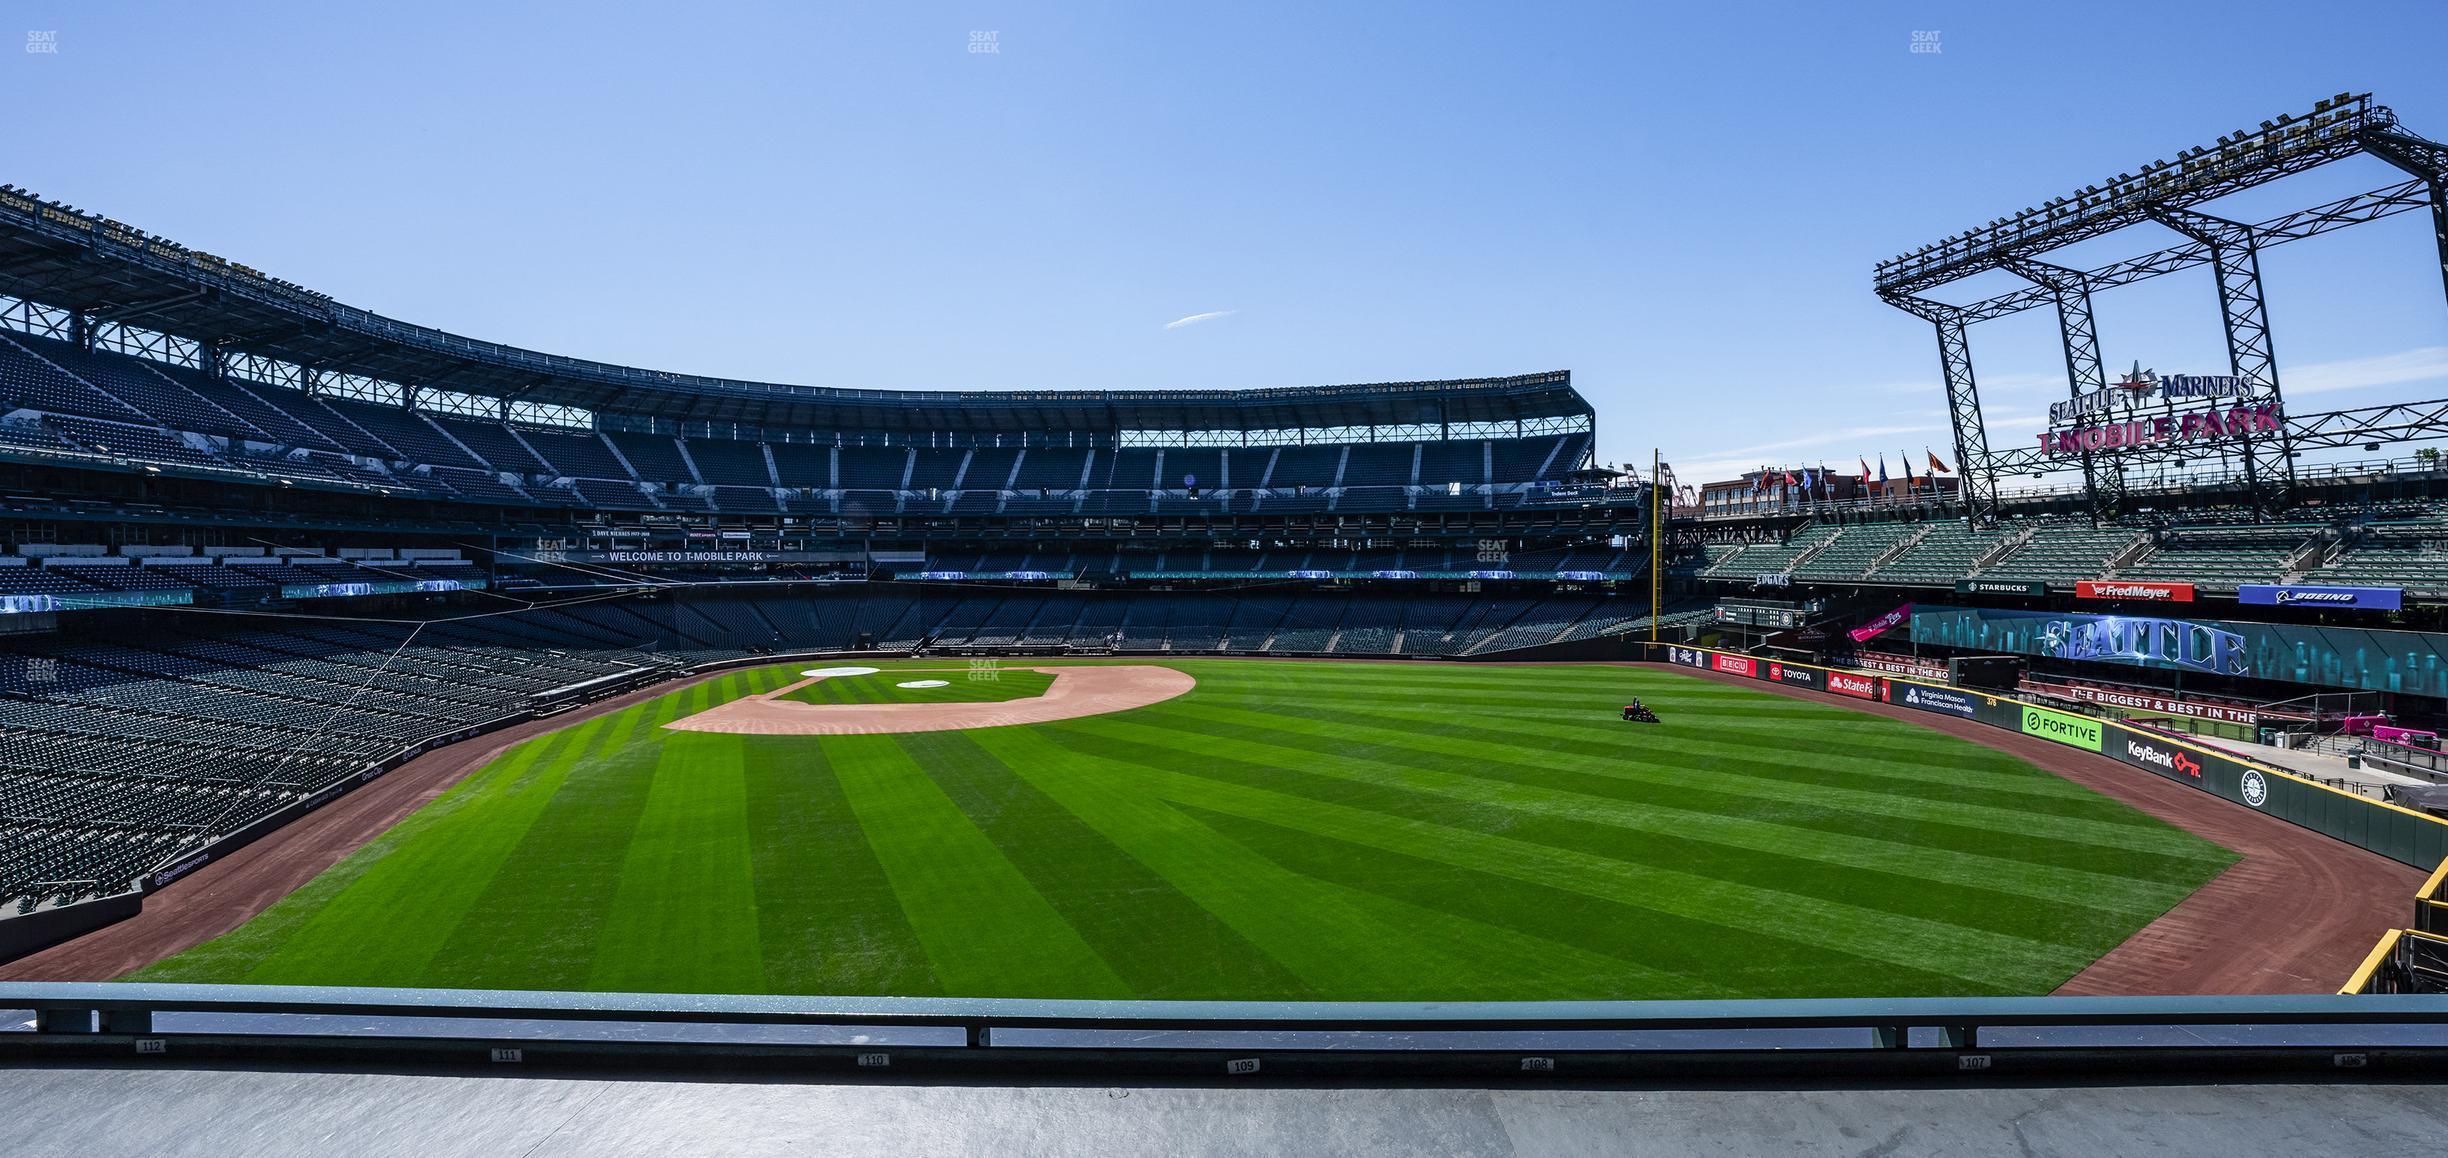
[663,663,1200,737]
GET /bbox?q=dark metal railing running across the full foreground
[0,982,2448,1080]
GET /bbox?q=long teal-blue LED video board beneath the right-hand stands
[1912,602,2448,695]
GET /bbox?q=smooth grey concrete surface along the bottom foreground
[5,1065,2448,1158]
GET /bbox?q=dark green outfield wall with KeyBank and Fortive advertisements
[1648,644,2448,869]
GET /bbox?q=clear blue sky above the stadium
[0,0,2448,480]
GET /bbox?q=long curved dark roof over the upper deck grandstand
[0,186,1596,436]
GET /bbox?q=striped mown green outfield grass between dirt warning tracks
[135,659,2233,999]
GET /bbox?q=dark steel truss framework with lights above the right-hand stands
[1873,93,2448,521]
